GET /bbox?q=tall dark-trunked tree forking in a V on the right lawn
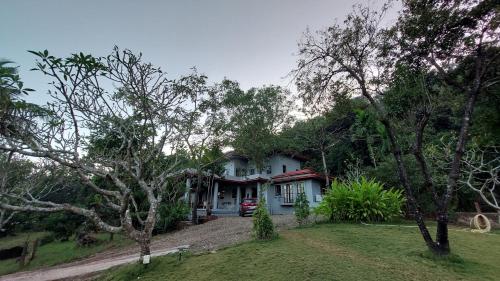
[294,0,499,255]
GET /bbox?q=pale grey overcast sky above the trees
[0,0,396,103]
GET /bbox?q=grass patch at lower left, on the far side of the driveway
[0,233,133,275]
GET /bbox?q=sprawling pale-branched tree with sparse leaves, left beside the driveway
[0,48,186,259]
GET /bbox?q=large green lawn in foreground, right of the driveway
[102,224,500,281]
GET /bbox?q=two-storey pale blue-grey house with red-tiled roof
[186,152,325,214]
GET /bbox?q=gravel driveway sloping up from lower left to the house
[0,215,296,281]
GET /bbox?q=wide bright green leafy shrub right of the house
[315,177,405,222]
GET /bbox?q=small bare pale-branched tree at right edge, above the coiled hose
[460,147,500,223]
